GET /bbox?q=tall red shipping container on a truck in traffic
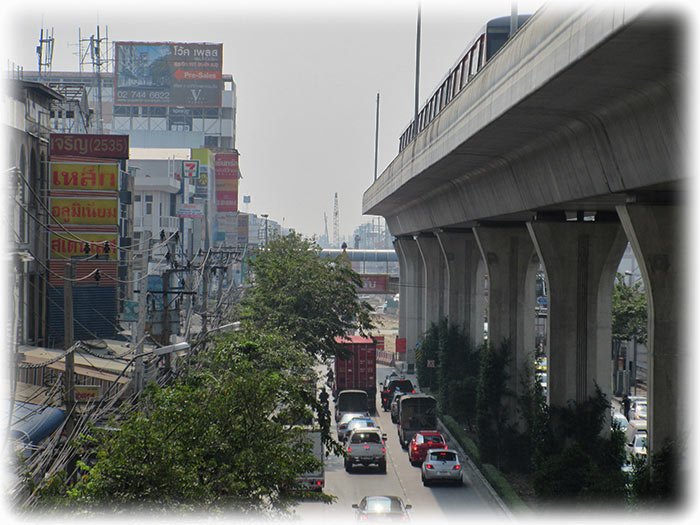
[333,335,384,414]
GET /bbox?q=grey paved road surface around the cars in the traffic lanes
[296,366,507,524]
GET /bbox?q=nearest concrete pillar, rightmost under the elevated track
[617,204,692,453]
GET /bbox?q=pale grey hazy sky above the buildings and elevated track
[0,0,688,239]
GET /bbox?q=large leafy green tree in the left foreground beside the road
[38,334,340,513]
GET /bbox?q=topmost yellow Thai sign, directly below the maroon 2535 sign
[49,162,119,191]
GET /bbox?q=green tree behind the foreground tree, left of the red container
[239,232,373,359]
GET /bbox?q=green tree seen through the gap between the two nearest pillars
[612,273,647,344]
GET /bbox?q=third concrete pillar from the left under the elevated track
[436,230,486,347]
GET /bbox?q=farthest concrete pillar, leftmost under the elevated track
[395,237,425,369]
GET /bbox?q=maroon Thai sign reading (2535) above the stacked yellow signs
[49,133,129,159]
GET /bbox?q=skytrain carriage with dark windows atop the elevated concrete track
[399,15,532,152]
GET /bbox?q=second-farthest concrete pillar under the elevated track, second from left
[416,233,445,333]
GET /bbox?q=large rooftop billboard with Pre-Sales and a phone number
[114,42,223,107]
